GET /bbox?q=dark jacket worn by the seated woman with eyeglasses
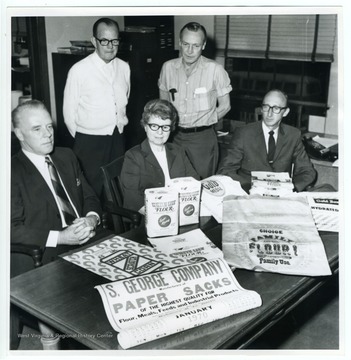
[121,139,200,210]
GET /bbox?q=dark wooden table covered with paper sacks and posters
[10,222,339,350]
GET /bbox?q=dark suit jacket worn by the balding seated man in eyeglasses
[218,121,317,191]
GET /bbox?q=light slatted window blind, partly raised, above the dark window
[215,14,337,62]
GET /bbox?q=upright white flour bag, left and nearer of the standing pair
[145,187,179,237]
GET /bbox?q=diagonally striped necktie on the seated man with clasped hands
[45,156,77,225]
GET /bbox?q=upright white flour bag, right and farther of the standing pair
[169,177,201,226]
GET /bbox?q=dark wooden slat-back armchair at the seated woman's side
[100,156,142,234]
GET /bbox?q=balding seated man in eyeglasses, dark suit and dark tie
[218,90,317,192]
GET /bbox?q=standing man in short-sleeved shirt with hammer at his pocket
[159,22,232,179]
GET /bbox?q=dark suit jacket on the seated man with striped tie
[11,148,101,253]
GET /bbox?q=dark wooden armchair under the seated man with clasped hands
[10,244,43,350]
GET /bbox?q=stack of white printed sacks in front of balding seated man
[250,171,294,197]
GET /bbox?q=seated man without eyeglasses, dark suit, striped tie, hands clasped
[11,100,106,263]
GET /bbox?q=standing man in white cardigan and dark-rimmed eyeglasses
[63,18,130,198]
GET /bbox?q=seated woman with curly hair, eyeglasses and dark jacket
[121,99,200,213]
